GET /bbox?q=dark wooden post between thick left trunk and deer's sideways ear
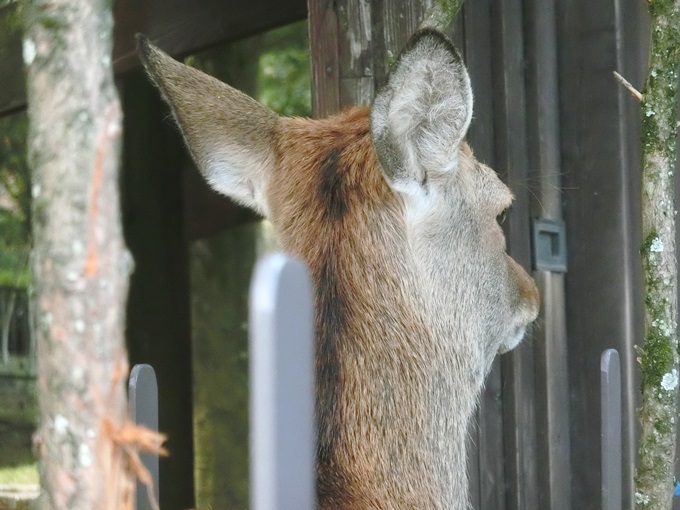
[121,73,194,510]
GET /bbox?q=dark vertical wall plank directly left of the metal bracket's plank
[491,0,539,510]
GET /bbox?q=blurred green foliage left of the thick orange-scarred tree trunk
[0,113,31,287]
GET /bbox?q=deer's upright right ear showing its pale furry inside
[371,30,472,193]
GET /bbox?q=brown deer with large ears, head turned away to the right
[138,29,539,510]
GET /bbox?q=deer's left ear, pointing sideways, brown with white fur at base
[137,35,278,214]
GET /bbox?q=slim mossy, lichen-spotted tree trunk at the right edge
[635,0,680,509]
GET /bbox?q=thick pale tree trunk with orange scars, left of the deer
[24,0,133,510]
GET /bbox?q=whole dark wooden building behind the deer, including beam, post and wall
[0,0,664,510]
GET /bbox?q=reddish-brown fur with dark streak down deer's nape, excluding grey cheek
[267,108,436,508]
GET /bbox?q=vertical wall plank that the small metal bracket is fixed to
[524,0,572,510]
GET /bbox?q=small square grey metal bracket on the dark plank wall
[531,218,567,273]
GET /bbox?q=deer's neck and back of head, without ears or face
[270,109,481,509]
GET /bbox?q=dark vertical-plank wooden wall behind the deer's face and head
[308,0,646,510]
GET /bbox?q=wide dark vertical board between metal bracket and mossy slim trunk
[555,0,648,508]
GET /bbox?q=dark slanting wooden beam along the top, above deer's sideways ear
[0,0,307,115]
